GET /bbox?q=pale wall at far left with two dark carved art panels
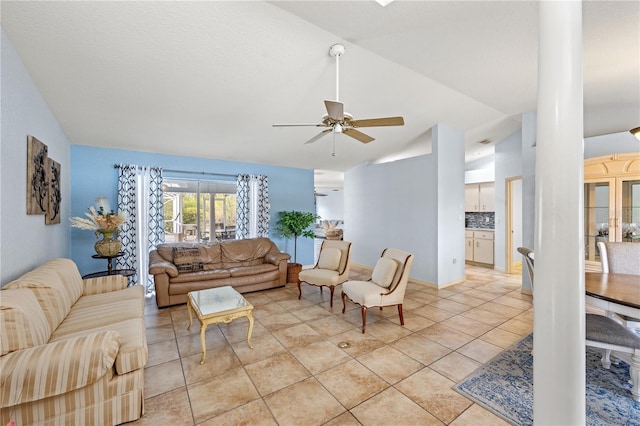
[0,29,71,285]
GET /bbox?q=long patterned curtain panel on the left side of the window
[116,165,164,295]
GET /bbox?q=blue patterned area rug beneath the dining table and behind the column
[454,334,640,426]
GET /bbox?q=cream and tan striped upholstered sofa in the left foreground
[0,259,147,425]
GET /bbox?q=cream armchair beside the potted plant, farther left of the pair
[298,240,351,307]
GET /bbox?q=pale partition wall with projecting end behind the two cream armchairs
[344,121,464,286]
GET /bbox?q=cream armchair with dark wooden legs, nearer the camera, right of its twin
[342,248,413,333]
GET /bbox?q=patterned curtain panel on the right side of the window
[236,175,271,239]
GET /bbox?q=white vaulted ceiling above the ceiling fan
[1,0,640,187]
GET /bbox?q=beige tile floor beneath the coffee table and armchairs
[131,266,533,426]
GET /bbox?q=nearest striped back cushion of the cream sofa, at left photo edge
[0,288,51,356]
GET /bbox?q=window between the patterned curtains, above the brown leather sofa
[163,178,236,242]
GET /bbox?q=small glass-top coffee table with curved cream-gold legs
[187,286,253,364]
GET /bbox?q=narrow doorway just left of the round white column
[506,177,522,275]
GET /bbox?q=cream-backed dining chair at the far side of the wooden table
[598,241,640,331]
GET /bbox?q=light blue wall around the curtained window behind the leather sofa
[70,145,315,274]
